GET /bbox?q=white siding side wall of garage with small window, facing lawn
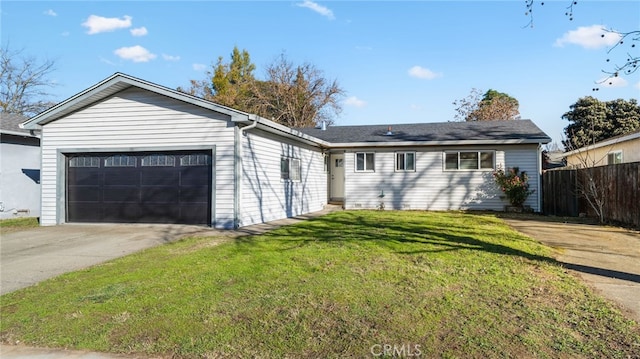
[239,130,327,226]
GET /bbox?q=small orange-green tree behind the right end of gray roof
[453,88,520,121]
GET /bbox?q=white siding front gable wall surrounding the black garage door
[41,88,234,228]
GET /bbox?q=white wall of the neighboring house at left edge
[0,140,40,219]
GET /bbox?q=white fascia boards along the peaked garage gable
[21,73,249,129]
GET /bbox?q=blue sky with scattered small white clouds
[0,0,640,146]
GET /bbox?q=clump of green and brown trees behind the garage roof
[178,47,344,127]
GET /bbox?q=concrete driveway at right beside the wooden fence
[503,217,640,323]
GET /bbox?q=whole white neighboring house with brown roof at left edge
[0,113,40,219]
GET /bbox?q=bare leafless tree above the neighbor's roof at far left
[0,45,55,117]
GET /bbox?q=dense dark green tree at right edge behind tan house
[562,96,640,150]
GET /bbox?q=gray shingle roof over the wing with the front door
[299,120,551,144]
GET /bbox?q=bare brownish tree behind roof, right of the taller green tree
[253,54,344,128]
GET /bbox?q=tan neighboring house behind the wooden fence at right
[564,131,640,168]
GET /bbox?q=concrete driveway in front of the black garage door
[0,224,222,294]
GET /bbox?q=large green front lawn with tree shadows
[0,211,640,358]
